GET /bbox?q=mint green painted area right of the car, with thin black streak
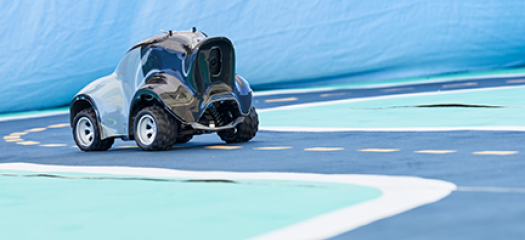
[259,87,525,128]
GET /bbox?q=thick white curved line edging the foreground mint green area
[0,163,456,240]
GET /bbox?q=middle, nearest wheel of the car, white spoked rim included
[133,106,179,151]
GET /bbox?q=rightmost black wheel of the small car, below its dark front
[218,106,259,143]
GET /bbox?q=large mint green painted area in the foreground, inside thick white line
[0,171,381,240]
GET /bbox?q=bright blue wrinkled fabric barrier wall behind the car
[0,0,525,112]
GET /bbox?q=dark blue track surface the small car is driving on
[0,75,525,239]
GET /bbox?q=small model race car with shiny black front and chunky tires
[70,28,259,151]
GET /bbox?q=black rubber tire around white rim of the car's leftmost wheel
[73,108,115,152]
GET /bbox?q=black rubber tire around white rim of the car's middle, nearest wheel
[133,106,179,151]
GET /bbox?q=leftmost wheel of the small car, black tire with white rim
[73,108,115,152]
